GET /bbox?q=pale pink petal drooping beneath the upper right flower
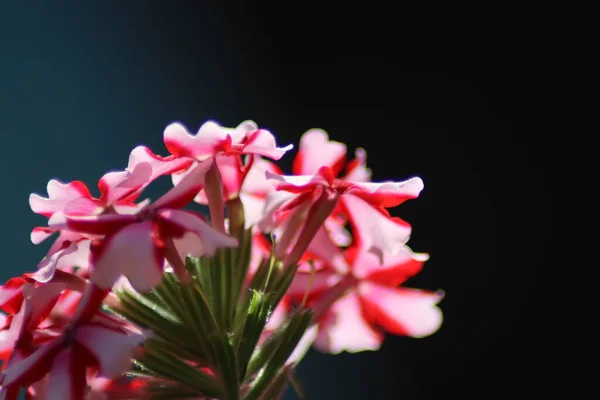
[341,194,411,264]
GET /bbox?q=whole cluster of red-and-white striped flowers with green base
[0,121,442,399]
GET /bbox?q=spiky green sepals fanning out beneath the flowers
[111,230,312,400]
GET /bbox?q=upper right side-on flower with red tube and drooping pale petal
[261,167,423,268]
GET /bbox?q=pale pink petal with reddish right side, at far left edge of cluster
[29,179,100,217]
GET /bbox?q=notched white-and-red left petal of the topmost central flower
[163,121,228,161]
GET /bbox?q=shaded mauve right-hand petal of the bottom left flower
[75,324,145,378]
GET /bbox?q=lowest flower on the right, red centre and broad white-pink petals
[289,246,443,354]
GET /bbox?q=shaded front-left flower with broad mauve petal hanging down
[50,163,237,292]
